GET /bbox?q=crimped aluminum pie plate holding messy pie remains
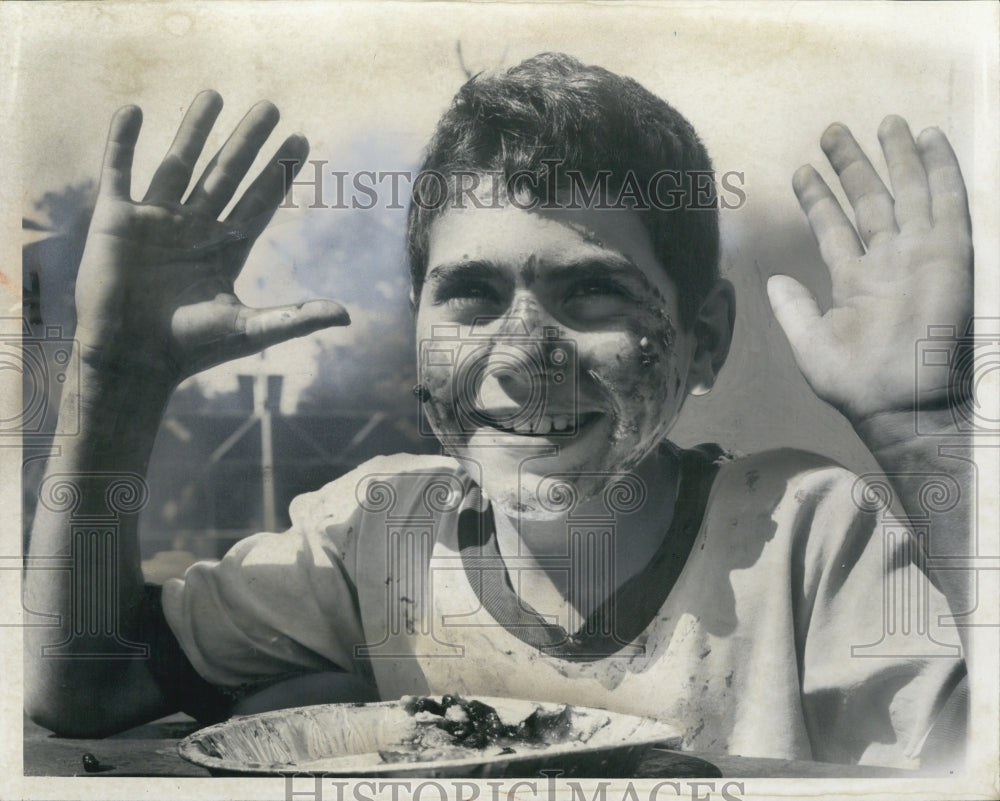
[178,696,681,778]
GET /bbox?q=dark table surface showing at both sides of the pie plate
[24,714,916,778]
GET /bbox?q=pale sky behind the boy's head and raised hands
[4,2,998,469]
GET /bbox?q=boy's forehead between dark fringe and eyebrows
[427,192,675,294]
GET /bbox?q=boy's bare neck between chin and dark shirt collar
[493,448,679,631]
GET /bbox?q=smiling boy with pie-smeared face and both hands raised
[26,55,972,766]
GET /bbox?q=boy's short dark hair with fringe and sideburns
[407,53,719,327]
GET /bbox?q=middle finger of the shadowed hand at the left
[187,101,279,217]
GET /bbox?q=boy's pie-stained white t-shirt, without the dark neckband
[163,450,965,767]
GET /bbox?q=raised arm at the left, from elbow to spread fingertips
[24,92,349,736]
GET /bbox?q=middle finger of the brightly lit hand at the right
[820,123,897,246]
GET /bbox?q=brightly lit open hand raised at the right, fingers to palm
[767,116,973,425]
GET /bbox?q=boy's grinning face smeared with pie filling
[417,191,694,518]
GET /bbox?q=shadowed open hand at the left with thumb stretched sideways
[76,92,350,386]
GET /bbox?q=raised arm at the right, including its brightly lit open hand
[768,117,975,612]
